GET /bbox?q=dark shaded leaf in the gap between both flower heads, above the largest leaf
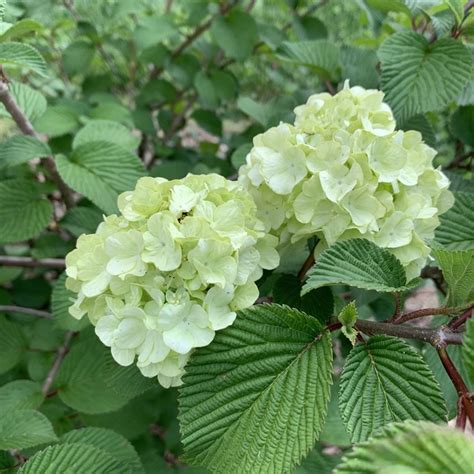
[273,273,334,323]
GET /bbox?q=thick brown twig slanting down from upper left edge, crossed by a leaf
[0,80,74,207]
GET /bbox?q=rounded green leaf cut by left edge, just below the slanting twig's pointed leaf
[0,178,53,243]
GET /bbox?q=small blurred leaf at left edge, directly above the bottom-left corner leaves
[0,380,44,416]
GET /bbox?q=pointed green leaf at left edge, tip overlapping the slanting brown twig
[0,135,51,170]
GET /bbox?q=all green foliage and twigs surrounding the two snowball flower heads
[0,0,474,474]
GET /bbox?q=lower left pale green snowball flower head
[66,174,279,387]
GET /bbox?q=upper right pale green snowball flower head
[239,83,453,278]
